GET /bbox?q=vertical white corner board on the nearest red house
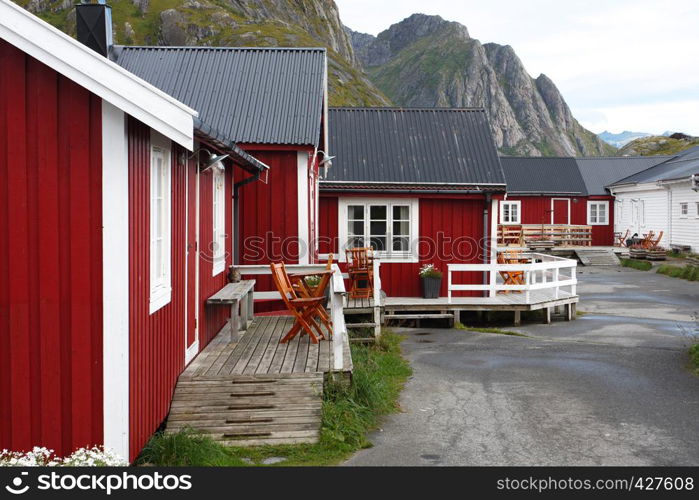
[102,102,129,460]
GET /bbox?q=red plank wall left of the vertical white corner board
[0,40,103,454]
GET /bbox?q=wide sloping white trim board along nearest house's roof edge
[0,0,197,151]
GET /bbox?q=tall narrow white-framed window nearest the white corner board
[150,131,172,314]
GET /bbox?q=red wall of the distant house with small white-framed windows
[506,196,614,246]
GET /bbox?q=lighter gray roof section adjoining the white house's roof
[576,156,672,195]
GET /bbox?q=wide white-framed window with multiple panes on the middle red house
[338,198,419,262]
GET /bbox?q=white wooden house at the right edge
[609,147,699,252]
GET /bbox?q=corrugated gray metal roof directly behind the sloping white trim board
[112,46,326,146]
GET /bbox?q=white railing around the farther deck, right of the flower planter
[447,253,578,303]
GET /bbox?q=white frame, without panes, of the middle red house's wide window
[338,198,420,262]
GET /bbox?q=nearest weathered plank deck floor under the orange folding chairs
[180,316,352,380]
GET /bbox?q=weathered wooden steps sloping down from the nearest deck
[166,372,323,446]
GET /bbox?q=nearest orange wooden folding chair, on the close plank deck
[269,262,325,344]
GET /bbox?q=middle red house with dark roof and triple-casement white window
[319,108,505,297]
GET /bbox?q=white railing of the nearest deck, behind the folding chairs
[233,264,347,371]
